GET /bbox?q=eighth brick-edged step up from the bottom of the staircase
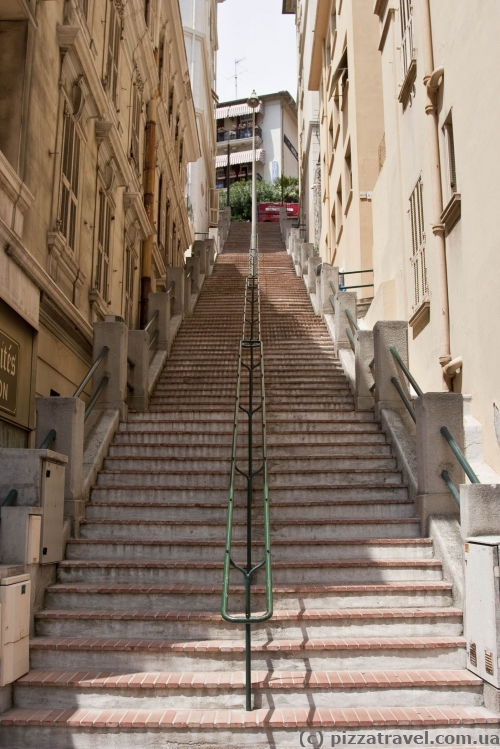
[80,518,420,542]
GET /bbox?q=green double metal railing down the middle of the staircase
[221,243,273,710]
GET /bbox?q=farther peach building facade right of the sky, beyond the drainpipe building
[307,0,383,296]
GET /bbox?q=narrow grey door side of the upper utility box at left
[40,460,65,564]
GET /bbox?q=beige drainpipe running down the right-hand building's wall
[421,0,451,390]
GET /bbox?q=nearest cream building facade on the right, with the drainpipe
[366,0,500,472]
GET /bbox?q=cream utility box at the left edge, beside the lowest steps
[0,575,31,687]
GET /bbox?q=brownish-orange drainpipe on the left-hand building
[140,93,158,330]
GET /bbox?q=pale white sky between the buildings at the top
[217,0,297,102]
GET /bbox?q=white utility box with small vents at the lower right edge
[465,536,500,689]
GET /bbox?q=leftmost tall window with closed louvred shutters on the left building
[58,112,81,251]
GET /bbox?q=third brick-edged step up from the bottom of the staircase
[30,637,466,671]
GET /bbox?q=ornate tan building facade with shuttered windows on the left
[0,0,201,447]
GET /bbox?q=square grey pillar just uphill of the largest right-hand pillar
[374,318,408,422]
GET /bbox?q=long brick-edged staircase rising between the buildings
[0,224,500,749]
